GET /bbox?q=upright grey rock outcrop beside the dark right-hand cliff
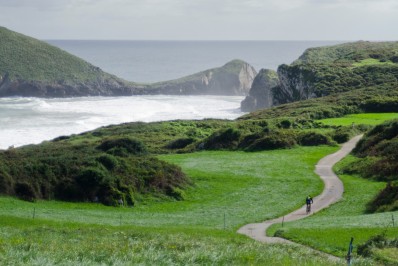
[241,69,279,112]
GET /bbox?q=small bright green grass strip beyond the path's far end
[318,113,398,126]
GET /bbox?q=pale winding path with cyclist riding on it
[238,135,362,243]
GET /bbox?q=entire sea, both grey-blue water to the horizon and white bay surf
[0,40,338,149]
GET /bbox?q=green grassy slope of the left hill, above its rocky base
[0,27,122,84]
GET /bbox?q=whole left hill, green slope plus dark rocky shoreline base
[0,27,146,97]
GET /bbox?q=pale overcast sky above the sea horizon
[0,0,398,40]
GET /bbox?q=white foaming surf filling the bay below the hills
[0,95,243,149]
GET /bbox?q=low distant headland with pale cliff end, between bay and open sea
[145,60,257,95]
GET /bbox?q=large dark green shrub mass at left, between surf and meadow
[0,137,188,205]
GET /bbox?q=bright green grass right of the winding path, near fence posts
[267,156,398,256]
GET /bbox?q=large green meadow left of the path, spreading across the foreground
[0,146,352,265]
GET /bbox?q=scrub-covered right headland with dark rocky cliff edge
[242,41,398,111]
